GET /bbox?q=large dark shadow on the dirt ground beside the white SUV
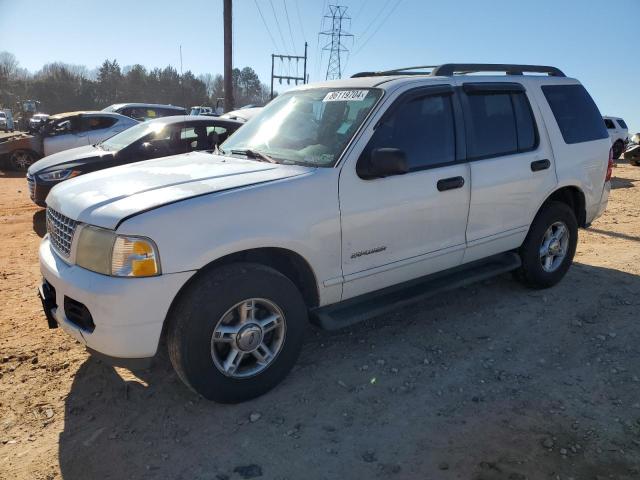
[59,264,640,480]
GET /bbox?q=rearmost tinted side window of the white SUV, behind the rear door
[542,85,609,144]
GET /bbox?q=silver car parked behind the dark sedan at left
[42,111,138,157]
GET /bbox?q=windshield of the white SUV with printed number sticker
[221,88,382,167]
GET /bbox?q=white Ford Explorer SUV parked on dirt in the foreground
[40,64,612,402]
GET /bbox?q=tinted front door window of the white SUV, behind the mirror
[367,96,456,170]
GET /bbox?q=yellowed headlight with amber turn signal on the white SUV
[76,226,160,277]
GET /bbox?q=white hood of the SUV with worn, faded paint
[47,152,314,229]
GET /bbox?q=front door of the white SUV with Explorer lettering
[339,85,471,299]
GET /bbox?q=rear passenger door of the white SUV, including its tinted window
[457,77,557,262]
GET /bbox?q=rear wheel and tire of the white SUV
[514,202,578,288]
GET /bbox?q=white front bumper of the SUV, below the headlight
[39,236,194,366]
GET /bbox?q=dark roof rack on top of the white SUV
[351,63,566,78]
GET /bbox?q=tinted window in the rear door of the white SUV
[465,91,538,159]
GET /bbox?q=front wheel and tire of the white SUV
[167,263,308,403]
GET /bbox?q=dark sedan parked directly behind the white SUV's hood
[27,115,244,206]
